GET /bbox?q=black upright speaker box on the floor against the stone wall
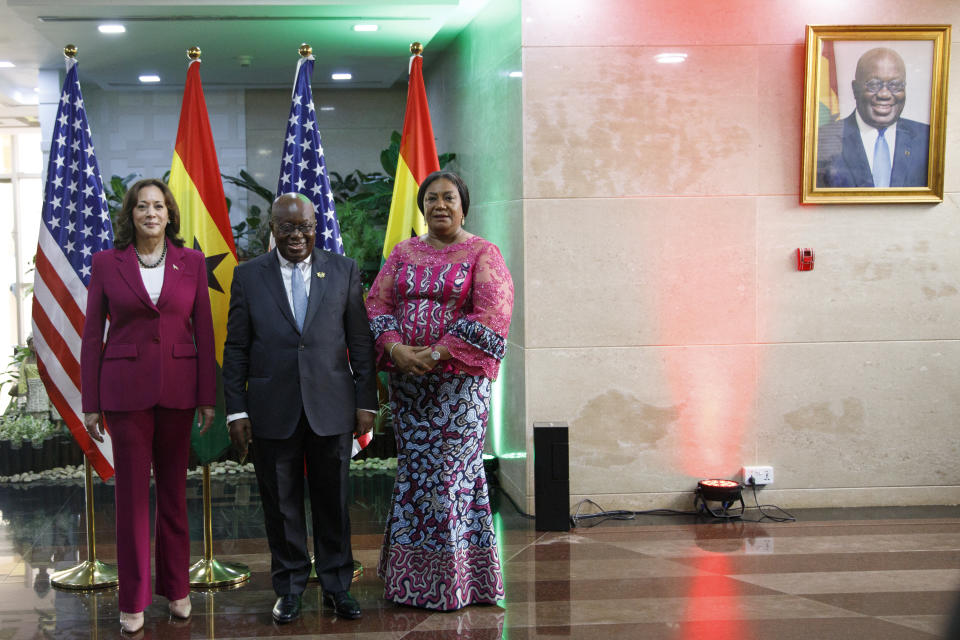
[533,422,570,531]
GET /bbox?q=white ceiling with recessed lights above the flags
[0,0,488,127]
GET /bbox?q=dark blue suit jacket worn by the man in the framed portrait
[817,113,930,188]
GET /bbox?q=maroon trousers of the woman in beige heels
[104,407,194,613]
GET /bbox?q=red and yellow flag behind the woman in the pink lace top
[383,48,440,260]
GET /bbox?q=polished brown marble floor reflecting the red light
[0,472,960,640]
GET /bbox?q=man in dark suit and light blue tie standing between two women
[223,194,377,623]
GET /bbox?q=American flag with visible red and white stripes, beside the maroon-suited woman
[33,58,113,480]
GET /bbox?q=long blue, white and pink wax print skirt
[377,373,503,611]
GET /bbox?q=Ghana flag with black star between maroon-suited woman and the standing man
[169,58,237,464]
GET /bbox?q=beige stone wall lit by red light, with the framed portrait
[510,0,960,509]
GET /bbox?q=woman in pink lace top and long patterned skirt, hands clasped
[367,171,513,611]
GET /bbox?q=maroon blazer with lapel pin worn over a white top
[80,242,216,413]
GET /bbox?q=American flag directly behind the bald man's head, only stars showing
[277,56,343,254]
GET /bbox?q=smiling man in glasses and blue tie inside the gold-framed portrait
[817,48,930,188]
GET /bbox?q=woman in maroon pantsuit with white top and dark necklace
[80,179,216,632]
